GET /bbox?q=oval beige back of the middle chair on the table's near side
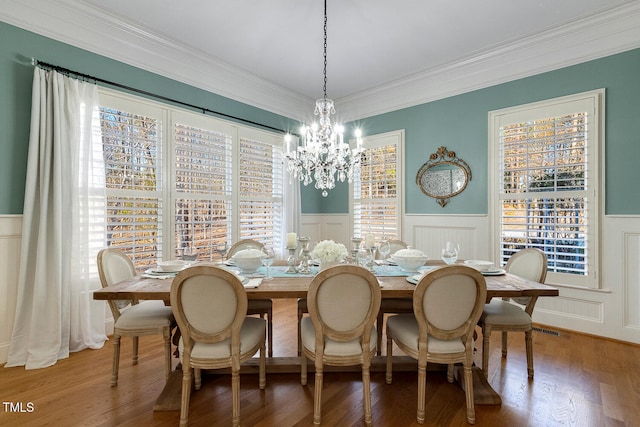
[307,265,380,353]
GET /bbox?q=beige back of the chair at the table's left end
[97,248,137,321]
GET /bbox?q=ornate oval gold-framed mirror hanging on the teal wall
[416,147,471,207]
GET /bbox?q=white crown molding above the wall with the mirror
[336,2,640,120]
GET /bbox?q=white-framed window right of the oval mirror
[489,91,604,287]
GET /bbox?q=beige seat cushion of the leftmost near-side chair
[178,317,266,360]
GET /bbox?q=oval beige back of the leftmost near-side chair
[170,266,247,354]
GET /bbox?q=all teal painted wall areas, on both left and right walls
[0,22,640,215]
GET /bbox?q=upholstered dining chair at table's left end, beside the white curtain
[97,248,175,386]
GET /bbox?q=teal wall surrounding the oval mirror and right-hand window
[316,49,640,215]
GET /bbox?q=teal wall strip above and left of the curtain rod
[0,22,300,215]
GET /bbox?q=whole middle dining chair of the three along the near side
[300,265,380,425]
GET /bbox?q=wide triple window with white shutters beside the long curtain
[100,90,284,268]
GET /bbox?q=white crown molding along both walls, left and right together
[0,0,640,121]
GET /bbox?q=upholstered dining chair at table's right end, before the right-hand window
[479,248,547,378]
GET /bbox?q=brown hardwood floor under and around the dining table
[0,300,640,427]
